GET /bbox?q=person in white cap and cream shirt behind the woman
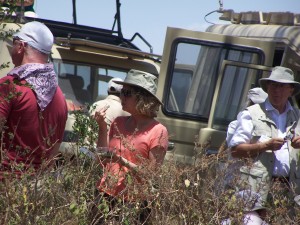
[91,78,130,129]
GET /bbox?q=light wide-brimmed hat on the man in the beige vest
[259,66,300,95]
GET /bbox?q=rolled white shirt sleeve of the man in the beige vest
[229,110,253,147]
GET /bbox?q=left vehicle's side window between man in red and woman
[53,59,127,108]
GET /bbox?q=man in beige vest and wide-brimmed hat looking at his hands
[229,66,300,224]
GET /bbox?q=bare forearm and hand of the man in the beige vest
[231,138,285,158]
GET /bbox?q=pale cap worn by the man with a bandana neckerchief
[13,21,54,54]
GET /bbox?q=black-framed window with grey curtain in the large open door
[163,39,264,121]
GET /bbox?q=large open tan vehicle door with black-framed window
[157,28,275,163]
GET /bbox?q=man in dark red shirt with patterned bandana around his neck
[0,21,67,179]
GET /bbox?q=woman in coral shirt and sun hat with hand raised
[95,70,168,222]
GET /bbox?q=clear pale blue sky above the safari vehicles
[34,0,300,54]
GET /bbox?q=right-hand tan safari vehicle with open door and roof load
[158,10,300,164]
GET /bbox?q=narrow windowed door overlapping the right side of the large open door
[199,60,272,154]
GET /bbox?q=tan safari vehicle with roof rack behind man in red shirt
[0,15,161,152]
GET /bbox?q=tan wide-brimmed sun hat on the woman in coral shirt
[114,69,162,104]
